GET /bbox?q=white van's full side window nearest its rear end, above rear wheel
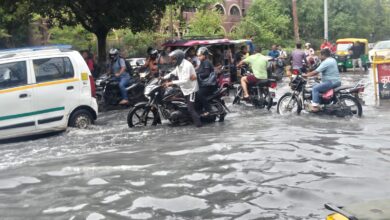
[33,57,74,83]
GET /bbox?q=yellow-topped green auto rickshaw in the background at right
[334,38,369,72]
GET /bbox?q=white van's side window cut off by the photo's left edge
[0,61,27,90]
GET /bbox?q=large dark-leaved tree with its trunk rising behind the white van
[4,0,179,70]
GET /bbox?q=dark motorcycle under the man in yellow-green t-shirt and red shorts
[233,66,277,110]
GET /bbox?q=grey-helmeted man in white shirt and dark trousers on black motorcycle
[164,50,202,127]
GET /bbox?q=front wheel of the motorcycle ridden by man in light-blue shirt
[277,93,302,115]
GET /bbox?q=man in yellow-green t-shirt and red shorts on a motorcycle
[237,48,268,101]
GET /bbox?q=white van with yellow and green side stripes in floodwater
[0,46,98,139]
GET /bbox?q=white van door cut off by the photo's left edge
[0,61,35,138]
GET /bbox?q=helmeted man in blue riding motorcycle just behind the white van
[108,48,131,105]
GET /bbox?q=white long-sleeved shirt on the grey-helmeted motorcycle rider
[164,59,199,96]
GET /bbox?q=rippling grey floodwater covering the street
[0,74,390,220]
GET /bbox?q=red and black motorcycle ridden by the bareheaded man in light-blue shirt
[277,70,365,117]
